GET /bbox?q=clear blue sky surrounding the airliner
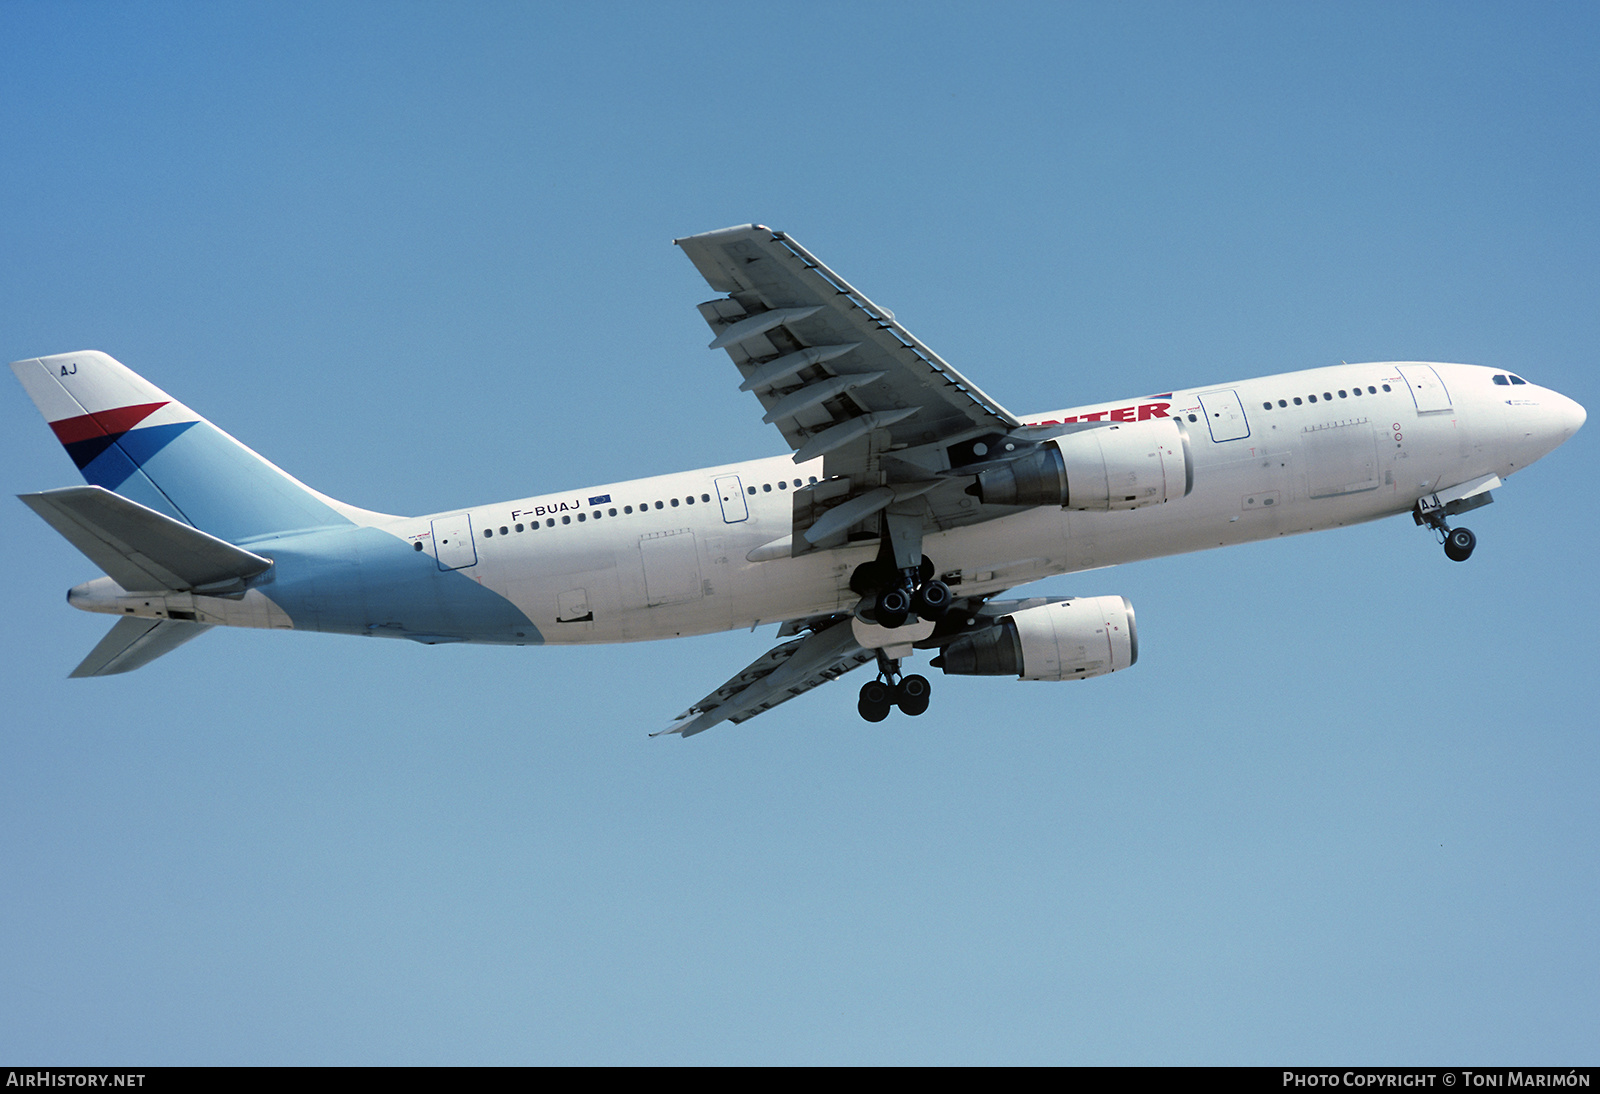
[0,3,1600,1065]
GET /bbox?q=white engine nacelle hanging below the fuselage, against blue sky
[933,597,1139,680]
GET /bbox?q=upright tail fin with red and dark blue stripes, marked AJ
[11,350,370,542]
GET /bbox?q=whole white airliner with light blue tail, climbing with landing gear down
[11,224,1586,737]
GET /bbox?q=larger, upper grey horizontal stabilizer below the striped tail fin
[19,486,272,594]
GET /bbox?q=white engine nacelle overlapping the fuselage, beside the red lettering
[978,417,1195,510]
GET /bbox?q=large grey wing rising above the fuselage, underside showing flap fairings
[675,224,1024,555]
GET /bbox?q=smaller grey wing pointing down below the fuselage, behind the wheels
[650,616,877,737]
